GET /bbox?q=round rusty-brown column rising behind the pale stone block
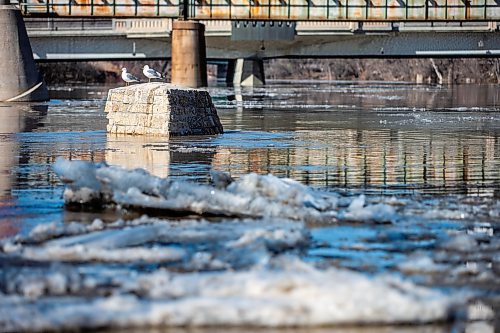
[170,20,207,88]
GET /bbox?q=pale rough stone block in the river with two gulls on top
[104,82,223,136]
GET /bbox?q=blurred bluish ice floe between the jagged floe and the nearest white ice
[3,217,309,270]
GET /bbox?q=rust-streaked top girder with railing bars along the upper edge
[19,0,500,21]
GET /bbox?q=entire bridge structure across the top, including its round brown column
[0,0,500,100]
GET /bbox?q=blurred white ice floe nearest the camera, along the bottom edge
[0,258,455,331]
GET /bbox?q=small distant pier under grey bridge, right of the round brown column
[226,58,266,87]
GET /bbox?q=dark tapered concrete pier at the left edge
[0,0,49,102]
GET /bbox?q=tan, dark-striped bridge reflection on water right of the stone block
[210,129,500,193]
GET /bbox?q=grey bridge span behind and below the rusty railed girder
[25,18,500,61]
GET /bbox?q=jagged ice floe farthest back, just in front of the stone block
[54,159,406,222]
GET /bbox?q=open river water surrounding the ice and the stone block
[0,81,500,332]
